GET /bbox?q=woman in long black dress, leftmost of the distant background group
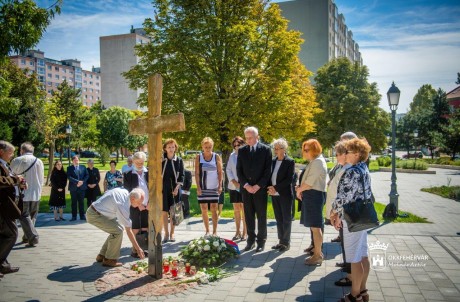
[50,160,67,221]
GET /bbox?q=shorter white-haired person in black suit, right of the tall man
[268,138,295,252]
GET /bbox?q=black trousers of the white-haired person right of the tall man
[272,195,292,246]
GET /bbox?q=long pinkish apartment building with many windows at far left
[10,50,101,107]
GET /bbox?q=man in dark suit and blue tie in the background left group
[67,155,89,221]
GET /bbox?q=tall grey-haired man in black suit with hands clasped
[236,127,272,252]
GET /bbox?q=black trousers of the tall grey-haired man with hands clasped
[241,188,268,245]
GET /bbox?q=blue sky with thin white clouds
[36,0,460,113]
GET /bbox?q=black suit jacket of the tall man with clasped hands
[236,142,272,188]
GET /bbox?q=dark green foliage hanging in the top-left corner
[0,0,62,61]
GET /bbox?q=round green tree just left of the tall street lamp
[314,58,390,150]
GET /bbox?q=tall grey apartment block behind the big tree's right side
[278,0,363,72]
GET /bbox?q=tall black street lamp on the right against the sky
[387,82,401,216]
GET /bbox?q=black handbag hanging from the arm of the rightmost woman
[343,170,379,232]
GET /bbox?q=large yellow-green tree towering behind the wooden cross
[124,0,317,154]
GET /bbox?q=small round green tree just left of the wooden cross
[96,106,134,161]
